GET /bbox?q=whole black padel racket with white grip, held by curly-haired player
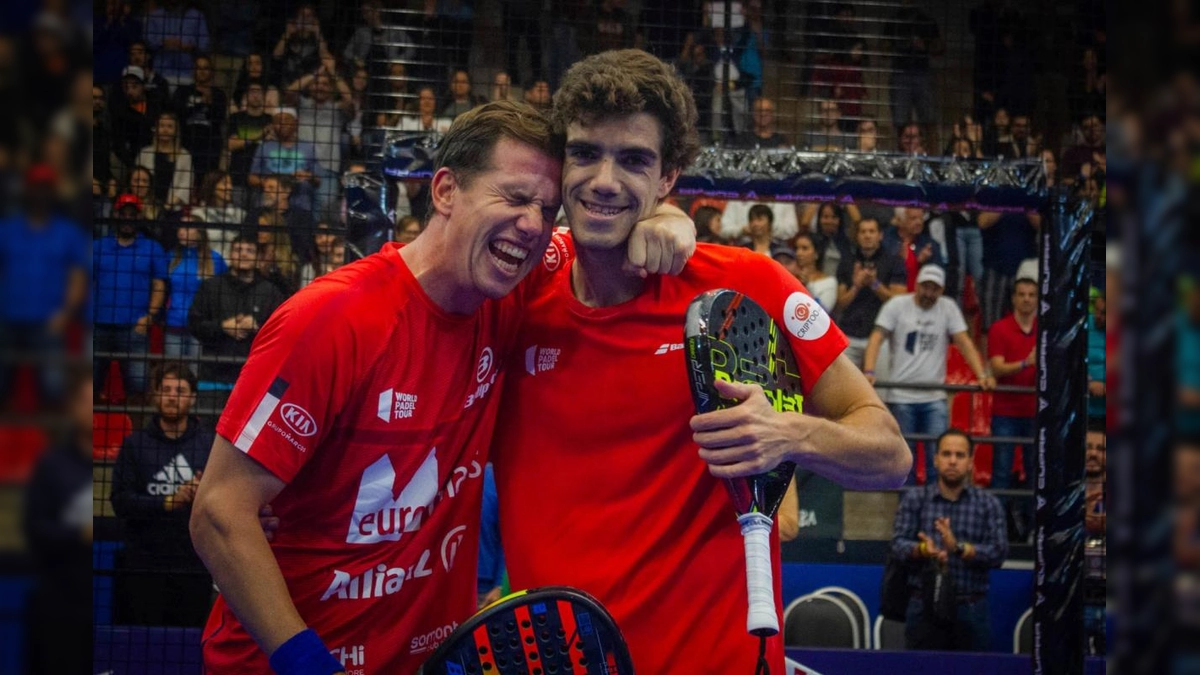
[684,288,803,638]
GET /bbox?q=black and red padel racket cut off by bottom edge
[418,586,634,675]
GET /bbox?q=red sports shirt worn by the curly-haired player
[492,244,846,675]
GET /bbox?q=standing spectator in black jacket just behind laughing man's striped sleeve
[187,234,286,410]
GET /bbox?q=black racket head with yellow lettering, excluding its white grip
[684,288,804,516]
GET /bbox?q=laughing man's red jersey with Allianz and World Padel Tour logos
[204,247,516,674]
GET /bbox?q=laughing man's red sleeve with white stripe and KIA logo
[217,293,365,483]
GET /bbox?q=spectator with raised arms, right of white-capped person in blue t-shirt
[288,66,353,209]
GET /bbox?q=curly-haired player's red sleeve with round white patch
[731,253,850,394]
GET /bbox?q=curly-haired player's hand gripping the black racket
[691,380,805,478]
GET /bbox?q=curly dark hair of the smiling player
[552,49,700,173]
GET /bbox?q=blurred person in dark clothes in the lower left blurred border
[22,374,94,673]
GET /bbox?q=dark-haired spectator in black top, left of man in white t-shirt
[827,219,905,367]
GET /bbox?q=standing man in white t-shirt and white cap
[863,264,996,485]
